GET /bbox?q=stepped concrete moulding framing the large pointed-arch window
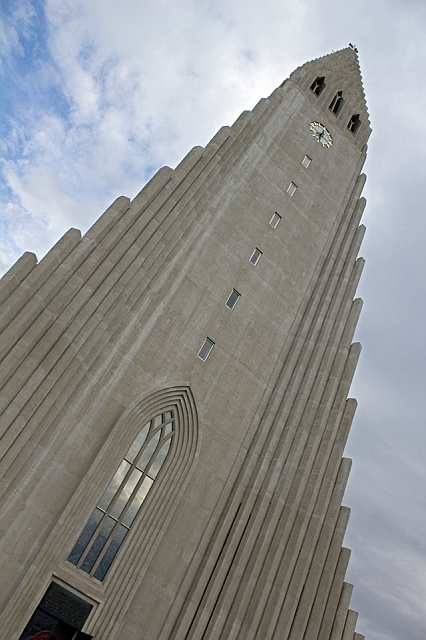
[62,386,200,596]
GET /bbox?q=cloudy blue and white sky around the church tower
[0,0,426,640]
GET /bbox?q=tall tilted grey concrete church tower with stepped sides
[0,47,371,640]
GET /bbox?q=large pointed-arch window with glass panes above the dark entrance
[68,411,174,580]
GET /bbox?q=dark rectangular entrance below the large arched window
[19,582,93,640]
